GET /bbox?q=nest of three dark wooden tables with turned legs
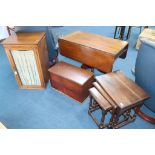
[88,71,149,128]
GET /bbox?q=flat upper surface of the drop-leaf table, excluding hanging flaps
[61,31,128,56]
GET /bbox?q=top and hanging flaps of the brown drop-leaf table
[59,32,128,73]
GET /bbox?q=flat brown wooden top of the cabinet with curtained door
[2,32,45,45]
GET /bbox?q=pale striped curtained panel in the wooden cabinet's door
[11,50,41,86]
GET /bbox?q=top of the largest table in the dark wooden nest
[96,71,149,109]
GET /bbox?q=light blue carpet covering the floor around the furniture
[0,26,155,129]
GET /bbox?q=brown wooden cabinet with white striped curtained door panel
[2,32,49,89]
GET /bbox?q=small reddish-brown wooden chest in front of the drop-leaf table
[49,62,94,103]
